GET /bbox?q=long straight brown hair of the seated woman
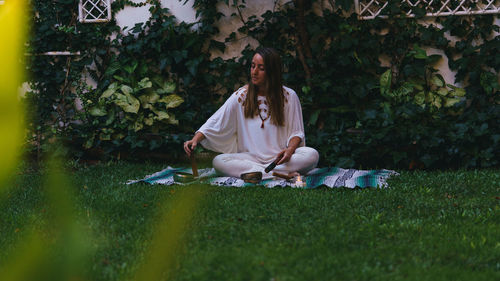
[243,47,285,126]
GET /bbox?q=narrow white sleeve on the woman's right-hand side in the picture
[285,88,306,147]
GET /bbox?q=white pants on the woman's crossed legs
[212,147,319,179]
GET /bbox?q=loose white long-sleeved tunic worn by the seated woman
[198,87,305,163]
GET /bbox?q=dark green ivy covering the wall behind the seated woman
[29,0,500,168]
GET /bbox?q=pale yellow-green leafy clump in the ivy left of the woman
[85,63,184,148]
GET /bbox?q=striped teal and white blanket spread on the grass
[127,166,399,189]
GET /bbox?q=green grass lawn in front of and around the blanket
[0,162,500,281]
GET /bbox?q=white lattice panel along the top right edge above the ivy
[354,0,500,20]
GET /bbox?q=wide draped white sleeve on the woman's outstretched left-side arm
[197,90,240,153]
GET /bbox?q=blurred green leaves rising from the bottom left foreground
[0,154,204,281]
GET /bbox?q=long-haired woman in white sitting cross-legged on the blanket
[184,48,319,179]
